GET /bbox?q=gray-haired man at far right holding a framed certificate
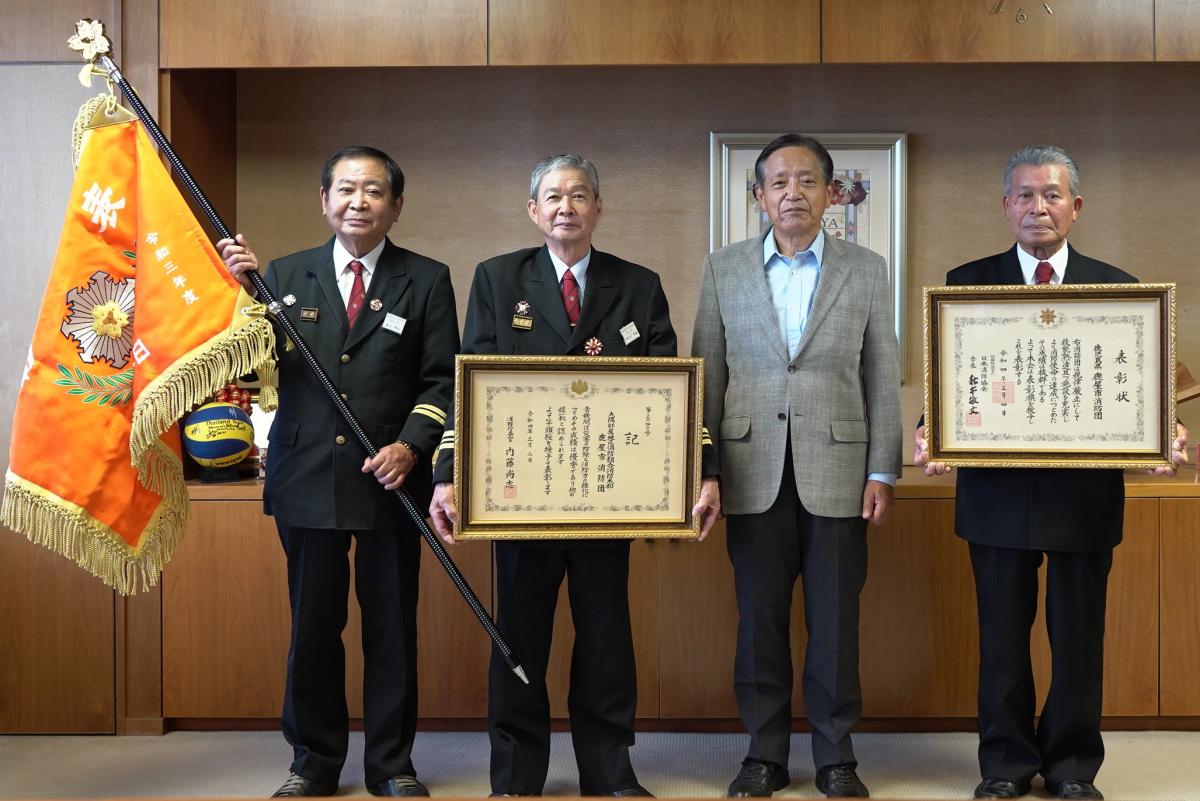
[914,145,1187,799]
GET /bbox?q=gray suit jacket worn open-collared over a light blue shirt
[692,234,901,517]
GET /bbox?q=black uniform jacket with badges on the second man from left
[433,246,676,482]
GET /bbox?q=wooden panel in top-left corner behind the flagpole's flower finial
[0,0,121,62]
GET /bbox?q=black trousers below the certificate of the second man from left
[487,542,637,795]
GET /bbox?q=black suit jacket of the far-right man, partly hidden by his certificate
[946,245,1138,552]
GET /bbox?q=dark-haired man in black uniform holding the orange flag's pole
[217,146,458,796]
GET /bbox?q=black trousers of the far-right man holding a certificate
[971,543,1112,783]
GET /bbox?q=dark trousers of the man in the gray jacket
[726,453,866,769]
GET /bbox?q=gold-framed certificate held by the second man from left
[454,355,704,540]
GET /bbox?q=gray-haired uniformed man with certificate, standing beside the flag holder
[430,155,716,796]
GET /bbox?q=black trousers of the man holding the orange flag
[278,526,421,783]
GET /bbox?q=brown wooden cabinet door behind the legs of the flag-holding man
[162,500,491,718]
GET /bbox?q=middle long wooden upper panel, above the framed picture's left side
[488,0,821,65]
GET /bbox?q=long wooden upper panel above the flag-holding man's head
[160,0,487,70]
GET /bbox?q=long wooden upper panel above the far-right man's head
[821,0,1154,64]
